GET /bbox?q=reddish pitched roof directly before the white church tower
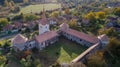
[35,31,58,43]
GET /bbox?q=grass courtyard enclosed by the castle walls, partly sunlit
[35,38,87,66]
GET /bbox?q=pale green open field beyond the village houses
[20,4,61,14]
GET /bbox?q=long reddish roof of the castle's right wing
[63,28,99,43]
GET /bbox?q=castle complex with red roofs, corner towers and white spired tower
[12,9,109,51]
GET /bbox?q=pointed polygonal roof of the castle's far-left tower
[12,34,28,44]
